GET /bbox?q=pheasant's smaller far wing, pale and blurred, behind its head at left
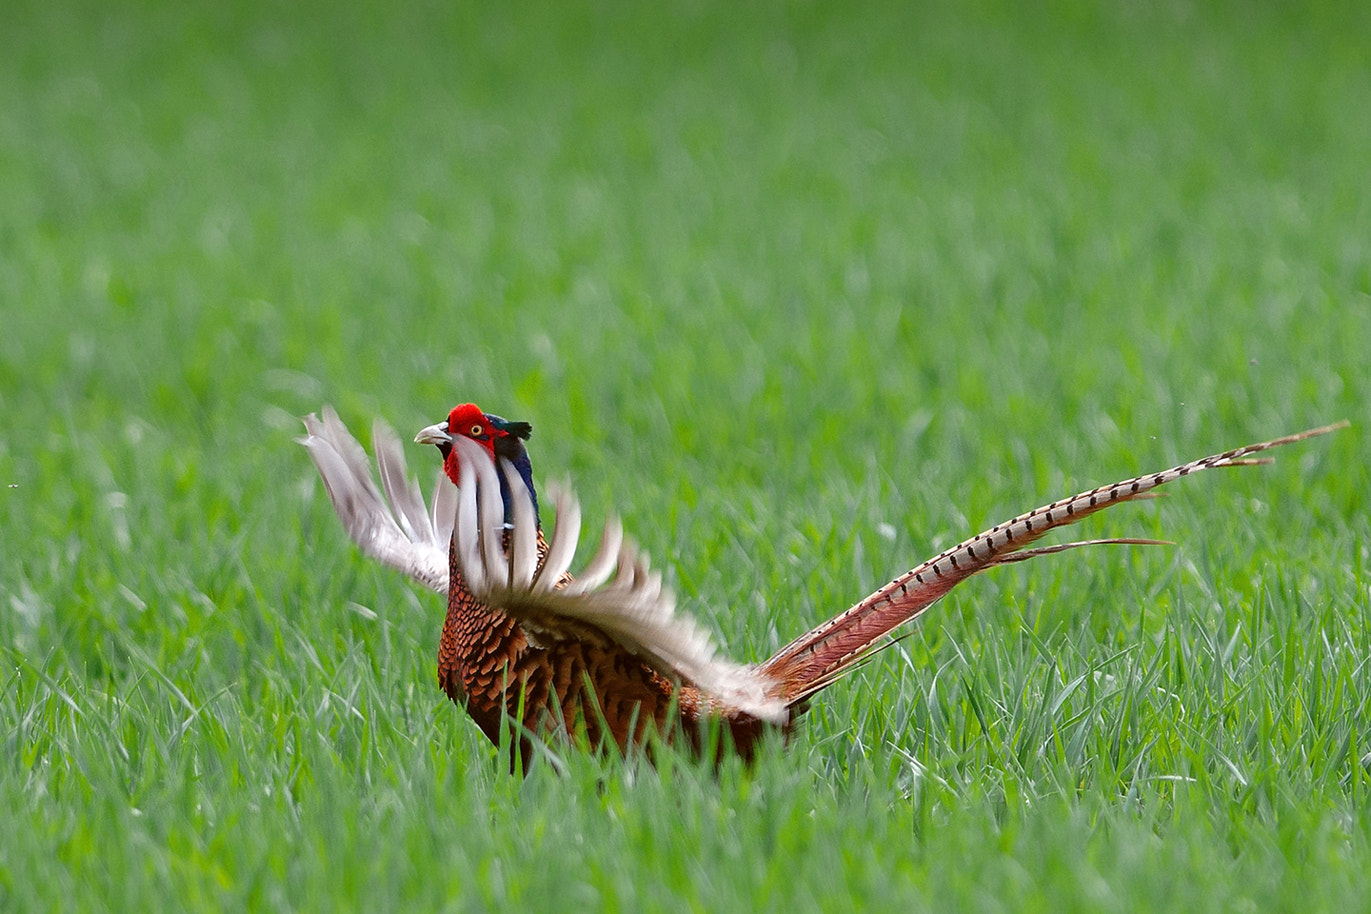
[299,406,457,595]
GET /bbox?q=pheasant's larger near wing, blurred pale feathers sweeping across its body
[452,437,788,722]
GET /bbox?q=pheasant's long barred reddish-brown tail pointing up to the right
[762,422,1348,703]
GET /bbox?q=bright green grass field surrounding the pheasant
[0,0,1371,911]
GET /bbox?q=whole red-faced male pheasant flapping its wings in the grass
[300,403,1348,770]
